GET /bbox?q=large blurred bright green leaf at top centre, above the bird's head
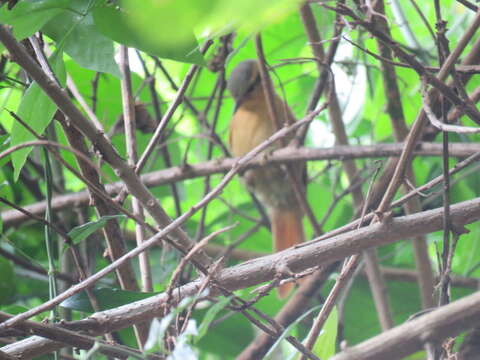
[94,0,300,65]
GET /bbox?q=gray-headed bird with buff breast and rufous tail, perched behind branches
[227,59,305,298]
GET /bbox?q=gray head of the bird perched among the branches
[227,60,260,105]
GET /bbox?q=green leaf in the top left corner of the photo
[0,0,71,40]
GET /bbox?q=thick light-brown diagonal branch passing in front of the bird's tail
[2,198,480,358]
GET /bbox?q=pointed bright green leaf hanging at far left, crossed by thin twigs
[11,51,66,180]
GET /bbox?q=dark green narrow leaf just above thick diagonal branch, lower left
[60,288,158,313]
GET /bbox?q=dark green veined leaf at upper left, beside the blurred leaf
[42,0,121,77]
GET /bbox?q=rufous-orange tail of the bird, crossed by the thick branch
[270,208,305,298]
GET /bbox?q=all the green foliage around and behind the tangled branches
[0,0,480,360]
